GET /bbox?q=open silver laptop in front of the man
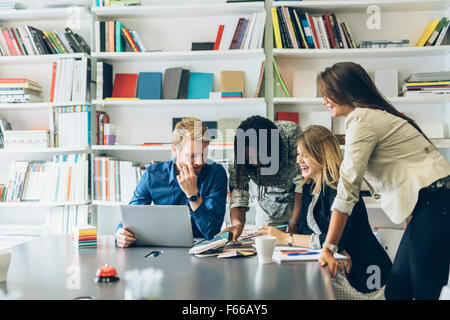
[120,205,194,247]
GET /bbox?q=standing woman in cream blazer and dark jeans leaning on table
[317,62,450,299]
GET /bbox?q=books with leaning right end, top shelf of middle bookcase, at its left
[95,21,147,52]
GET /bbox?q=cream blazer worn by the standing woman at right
[332,108,450,224]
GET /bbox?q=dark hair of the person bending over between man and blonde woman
[234,116,283,199]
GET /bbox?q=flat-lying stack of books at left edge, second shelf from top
[0,78,42,103]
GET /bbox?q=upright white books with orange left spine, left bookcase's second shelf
[50,58,90,102]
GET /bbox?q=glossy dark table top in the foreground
[0,236,334,300]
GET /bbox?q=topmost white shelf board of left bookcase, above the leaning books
[0,6,91,22]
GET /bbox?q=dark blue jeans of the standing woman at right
[385,189,450,300]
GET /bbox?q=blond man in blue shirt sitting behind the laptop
[116,118,228,248]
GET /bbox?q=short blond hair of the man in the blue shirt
[172,118,211,147]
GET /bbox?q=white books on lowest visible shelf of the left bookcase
[48,205,92,235]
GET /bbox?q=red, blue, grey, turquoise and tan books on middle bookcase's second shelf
[97,62,248,100]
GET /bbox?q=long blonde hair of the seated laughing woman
[298,125,342,194]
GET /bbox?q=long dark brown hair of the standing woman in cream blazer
[317,62,432,143]
